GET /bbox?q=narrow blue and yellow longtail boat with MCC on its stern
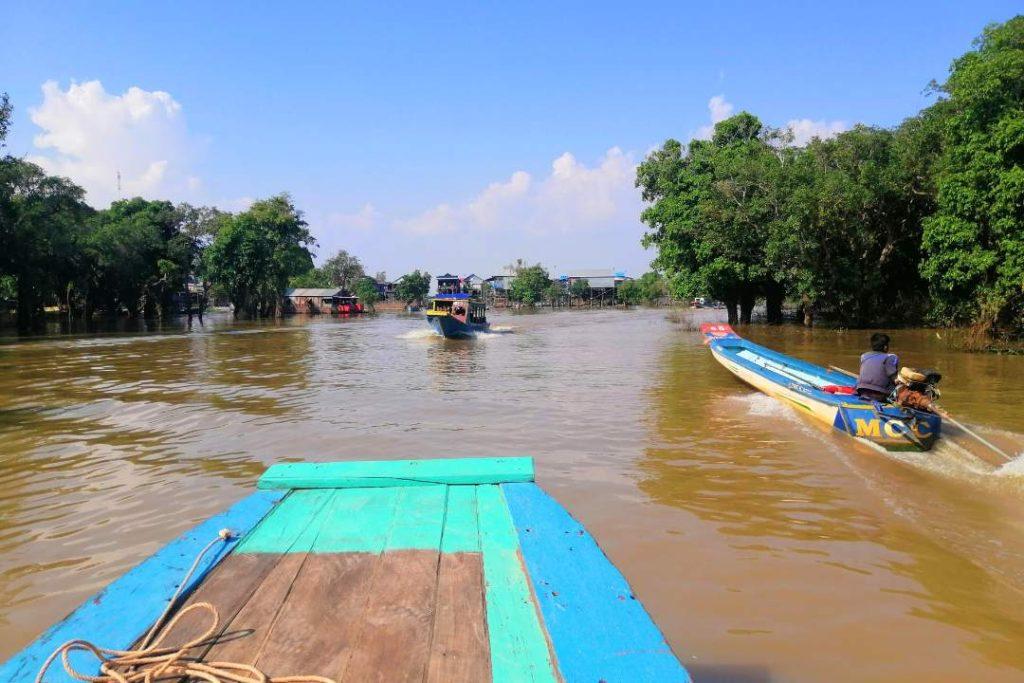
[700,323,942,451]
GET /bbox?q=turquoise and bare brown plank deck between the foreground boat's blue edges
[149,484,524,682]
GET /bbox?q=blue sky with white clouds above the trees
[0,0,1020,275]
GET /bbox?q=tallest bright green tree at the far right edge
[921,16,1024,331]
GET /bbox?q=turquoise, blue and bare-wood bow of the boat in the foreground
[0,458,689,683]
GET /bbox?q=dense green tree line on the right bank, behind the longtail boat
[636,16,1024,334]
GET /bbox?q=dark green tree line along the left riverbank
[0,93,430,329]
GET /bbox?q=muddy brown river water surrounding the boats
[0,310,1024,683]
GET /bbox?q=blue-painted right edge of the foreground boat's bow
[502,483,690,683]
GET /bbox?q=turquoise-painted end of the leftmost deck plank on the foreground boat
[238,490,334,553]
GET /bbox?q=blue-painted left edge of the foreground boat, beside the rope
[0,492,284,683]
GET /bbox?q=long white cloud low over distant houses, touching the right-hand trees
[395,147,641,234]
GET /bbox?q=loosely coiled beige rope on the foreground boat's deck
[36,528,335,683]
